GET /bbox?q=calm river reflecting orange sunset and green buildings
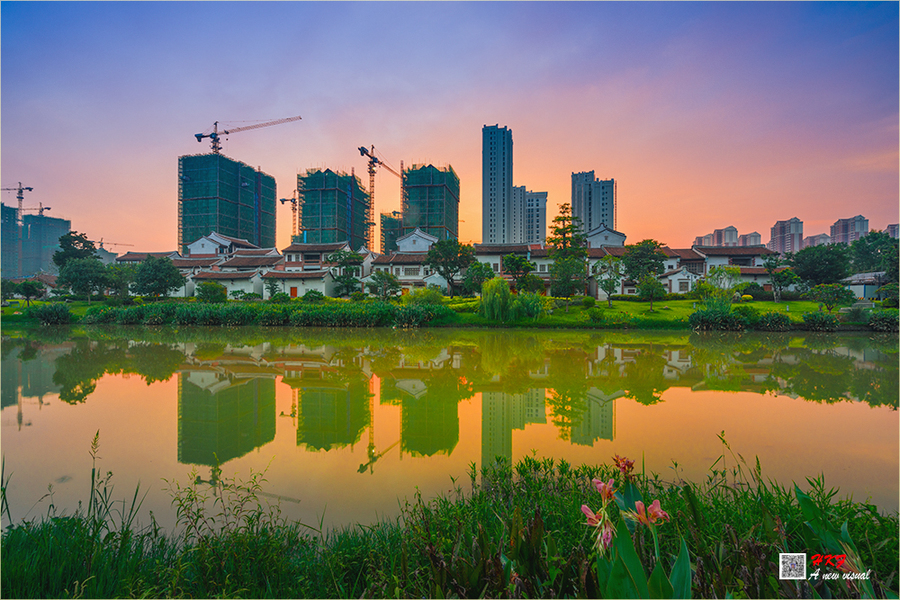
[2,327,900,528]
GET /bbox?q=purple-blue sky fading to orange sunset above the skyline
[0,2,900,254]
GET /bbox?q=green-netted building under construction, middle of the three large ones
[292,169,374,250]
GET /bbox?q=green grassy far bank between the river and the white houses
[3,298,897,331]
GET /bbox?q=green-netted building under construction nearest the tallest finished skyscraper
[401,165,459,240]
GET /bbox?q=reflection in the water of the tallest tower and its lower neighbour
[481,388,547,465]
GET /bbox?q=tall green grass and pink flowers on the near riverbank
[0,438,898,598]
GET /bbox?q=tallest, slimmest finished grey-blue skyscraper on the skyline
[481,125,513,244]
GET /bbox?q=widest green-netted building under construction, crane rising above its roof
[178,153,276,253]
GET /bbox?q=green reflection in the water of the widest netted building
[178,369,275,466]
